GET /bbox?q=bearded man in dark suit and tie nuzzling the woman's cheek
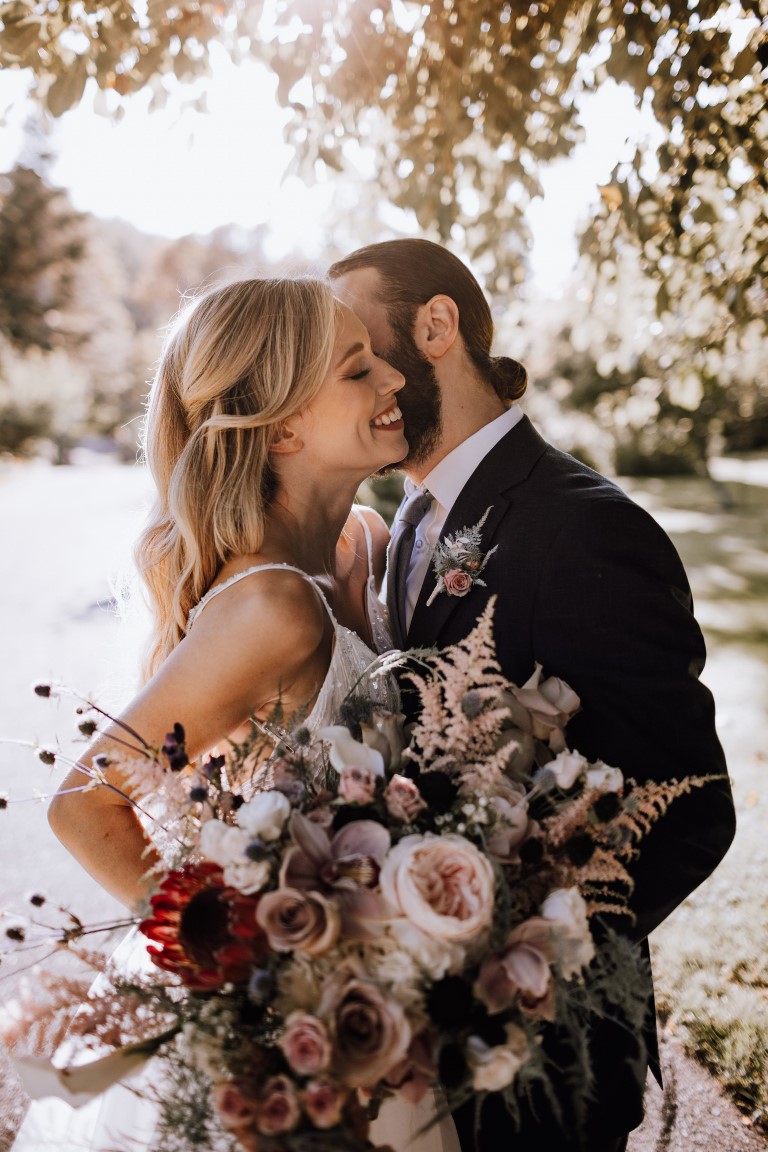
[329,240,735,1152]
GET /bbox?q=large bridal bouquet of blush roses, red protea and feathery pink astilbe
[0,604,702,1152]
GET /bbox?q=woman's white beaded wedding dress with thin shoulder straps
[10,515,461,1152]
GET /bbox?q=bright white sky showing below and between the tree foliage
[0,53,653,295]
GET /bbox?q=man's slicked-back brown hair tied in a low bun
[328,240,529,404]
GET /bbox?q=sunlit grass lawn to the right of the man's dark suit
[625,470,768,1131]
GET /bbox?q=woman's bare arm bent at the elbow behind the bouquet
[48,573,332,908]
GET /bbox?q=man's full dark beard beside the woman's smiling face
[377,333,442,476]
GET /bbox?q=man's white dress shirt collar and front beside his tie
[405,404,523,628]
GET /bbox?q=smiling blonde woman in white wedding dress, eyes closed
[8,278,457,1152]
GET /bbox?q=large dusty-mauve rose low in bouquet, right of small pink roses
[318,961,411,1087]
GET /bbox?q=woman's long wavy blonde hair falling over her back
[136,278,339,677]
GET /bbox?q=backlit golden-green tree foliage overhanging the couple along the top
[0,0,768,461]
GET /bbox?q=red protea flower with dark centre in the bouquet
[139,861,269,992]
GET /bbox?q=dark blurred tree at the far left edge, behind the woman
[0,161,84,350]
